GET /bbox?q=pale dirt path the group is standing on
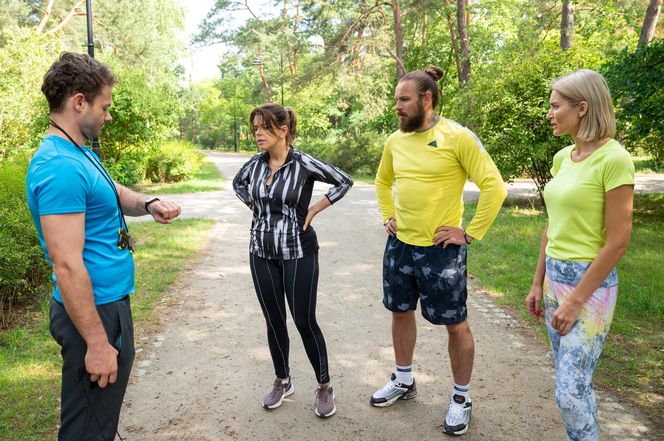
[120,154,654,441]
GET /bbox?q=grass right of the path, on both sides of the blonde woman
[465,194,664,420]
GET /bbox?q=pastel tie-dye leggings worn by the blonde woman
[544,257,618,441]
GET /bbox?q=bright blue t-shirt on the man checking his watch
[26,135,134,305]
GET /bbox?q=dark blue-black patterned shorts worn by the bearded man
[383,236,468,325]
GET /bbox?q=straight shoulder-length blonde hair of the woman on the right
[551,69,616,141]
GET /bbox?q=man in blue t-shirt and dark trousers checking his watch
[26,53,180,440]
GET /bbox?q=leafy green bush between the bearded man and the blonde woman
[457,43,587,192]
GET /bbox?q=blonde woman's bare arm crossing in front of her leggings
[551,185,634,335]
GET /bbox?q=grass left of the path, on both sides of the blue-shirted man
[0,219,213,441]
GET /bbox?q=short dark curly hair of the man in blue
[42,52,118,112]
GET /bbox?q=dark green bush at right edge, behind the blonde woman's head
[604,40,664,168]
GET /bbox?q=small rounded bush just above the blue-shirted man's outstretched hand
[145,141,202,182]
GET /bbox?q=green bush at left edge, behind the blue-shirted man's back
[0,159,50,323]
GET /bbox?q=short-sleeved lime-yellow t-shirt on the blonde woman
[544,139,634,262]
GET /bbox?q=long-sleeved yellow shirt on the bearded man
[376,118,507,246]
